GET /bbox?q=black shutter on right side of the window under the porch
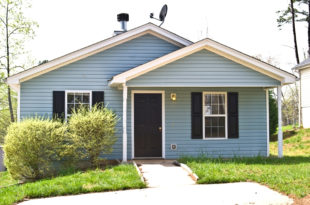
[227,93,239,138]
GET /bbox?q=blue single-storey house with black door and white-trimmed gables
[7,19,295,161]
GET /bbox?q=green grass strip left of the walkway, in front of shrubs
[0,165,145,205]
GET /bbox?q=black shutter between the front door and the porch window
[192,93,202,139]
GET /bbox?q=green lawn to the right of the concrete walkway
[181,156,310,198]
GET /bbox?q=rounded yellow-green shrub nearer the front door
[68,106,117,166]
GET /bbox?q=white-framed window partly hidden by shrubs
[65,91,91,119]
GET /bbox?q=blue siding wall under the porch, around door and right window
[128,88,267,159]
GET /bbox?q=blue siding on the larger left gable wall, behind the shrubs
[20,34,179,159]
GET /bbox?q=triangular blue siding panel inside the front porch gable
[128,50,280,87]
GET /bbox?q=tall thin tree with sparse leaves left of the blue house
[0,0,38,122]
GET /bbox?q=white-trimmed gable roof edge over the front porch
[109,38,296,86]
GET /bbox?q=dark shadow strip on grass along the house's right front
[179,155,310,165]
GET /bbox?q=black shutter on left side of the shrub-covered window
[53,91,65,119]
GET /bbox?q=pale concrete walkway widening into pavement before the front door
[20,161,293,205]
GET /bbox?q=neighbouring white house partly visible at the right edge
[293,58,310,128]
